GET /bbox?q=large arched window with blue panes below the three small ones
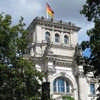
[53,77,70,93]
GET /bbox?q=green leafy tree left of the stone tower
[0,14,42,100]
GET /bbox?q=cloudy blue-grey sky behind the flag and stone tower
[0,0,93,43]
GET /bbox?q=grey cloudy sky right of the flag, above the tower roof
[49,0,93,43]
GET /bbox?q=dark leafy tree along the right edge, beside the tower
[81,0,100,100]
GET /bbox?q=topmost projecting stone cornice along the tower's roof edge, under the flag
[28,17,80,31]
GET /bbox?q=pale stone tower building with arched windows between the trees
[27,17,97,100]
